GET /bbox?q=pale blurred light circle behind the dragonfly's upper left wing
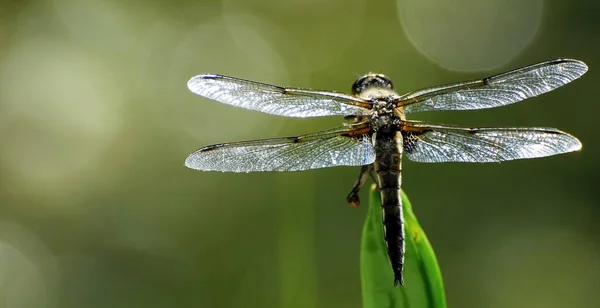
[172,15,288,143]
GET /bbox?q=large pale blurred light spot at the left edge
[0,39,124,193]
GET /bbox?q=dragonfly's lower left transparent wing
[185,129,375,172]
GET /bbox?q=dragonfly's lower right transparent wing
[403,122,581,163]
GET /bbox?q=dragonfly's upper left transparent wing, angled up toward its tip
[188,74,370,118]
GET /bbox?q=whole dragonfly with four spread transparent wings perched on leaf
[185,59,587,286]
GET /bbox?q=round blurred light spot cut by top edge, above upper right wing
[397,0,542,71]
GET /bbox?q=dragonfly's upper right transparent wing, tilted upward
[399,59,587,113]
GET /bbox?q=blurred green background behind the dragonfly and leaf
[0,0,600,308]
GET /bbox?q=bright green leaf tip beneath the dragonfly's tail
[360,185,446,308]
